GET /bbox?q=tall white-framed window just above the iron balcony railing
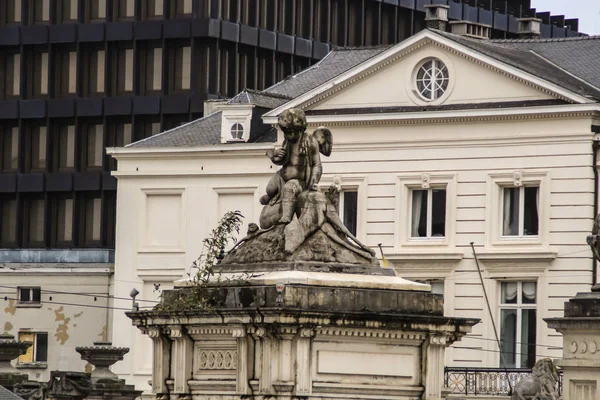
[500,282,537,368]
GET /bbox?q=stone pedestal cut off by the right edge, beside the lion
[545,287,600,400]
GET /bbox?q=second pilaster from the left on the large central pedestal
[169,326,194,394]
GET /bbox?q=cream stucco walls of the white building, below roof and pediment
[113,112,594,390]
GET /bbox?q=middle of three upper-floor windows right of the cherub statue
[410,188,446,238]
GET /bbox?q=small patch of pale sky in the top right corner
[531,0,600,35]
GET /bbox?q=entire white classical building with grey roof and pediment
[109,30,600,388]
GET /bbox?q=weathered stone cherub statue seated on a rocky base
[223,109,379,265]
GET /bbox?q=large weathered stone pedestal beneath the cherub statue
[127,265,478,400]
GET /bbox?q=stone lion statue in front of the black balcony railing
[511,358,561,400]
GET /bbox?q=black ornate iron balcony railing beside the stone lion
[444,367,562,396]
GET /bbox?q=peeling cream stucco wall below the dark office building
[0,263,112,381]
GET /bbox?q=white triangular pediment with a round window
[265,31,590,118]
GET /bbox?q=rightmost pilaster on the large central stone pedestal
[423,336,448,400]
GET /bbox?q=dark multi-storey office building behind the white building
[0,0,580,255]
